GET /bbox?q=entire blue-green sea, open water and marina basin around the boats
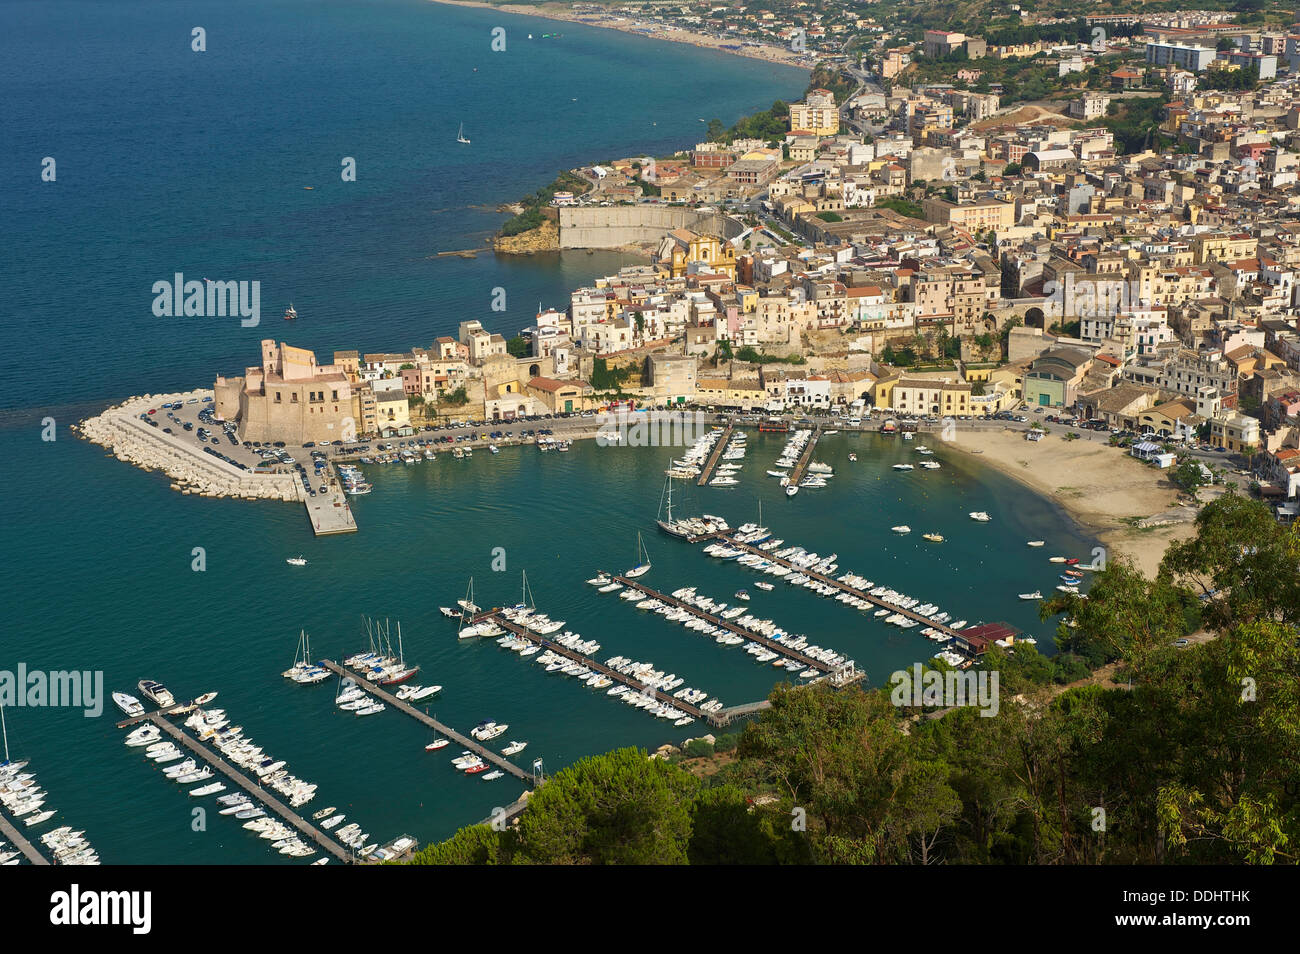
[0,0,1093,864]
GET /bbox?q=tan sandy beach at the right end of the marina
[944,429,1196,577]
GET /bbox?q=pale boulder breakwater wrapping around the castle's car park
[73,390,300,500]
